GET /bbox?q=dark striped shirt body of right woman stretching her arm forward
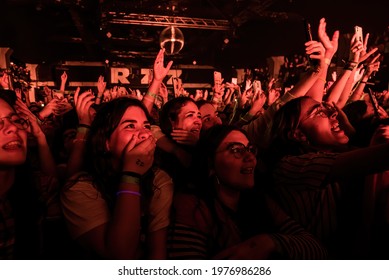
[274,153,344,249]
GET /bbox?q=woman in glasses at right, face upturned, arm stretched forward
[268,97,389,258]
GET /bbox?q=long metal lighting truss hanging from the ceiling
[106,12,231,30]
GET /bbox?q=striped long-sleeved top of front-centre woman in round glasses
[167,195,327,259]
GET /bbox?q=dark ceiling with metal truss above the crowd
[0,0,389,66]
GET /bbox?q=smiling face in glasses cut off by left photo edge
[0,99,27,168]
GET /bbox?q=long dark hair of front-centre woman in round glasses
[189,125,273,241]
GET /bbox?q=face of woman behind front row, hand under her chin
[173,102,202,135]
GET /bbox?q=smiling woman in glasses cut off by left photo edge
[0,91,59,259]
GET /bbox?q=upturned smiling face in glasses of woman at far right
[298,99,349,148]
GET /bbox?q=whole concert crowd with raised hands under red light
[0,18,389,260]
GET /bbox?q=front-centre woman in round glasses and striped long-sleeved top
[168,125,326,259]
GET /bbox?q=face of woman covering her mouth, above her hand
[106,106,152,162]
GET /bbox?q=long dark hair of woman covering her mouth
[85,97,153,207]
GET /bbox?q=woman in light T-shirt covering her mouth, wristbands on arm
[61,97,173,259]
